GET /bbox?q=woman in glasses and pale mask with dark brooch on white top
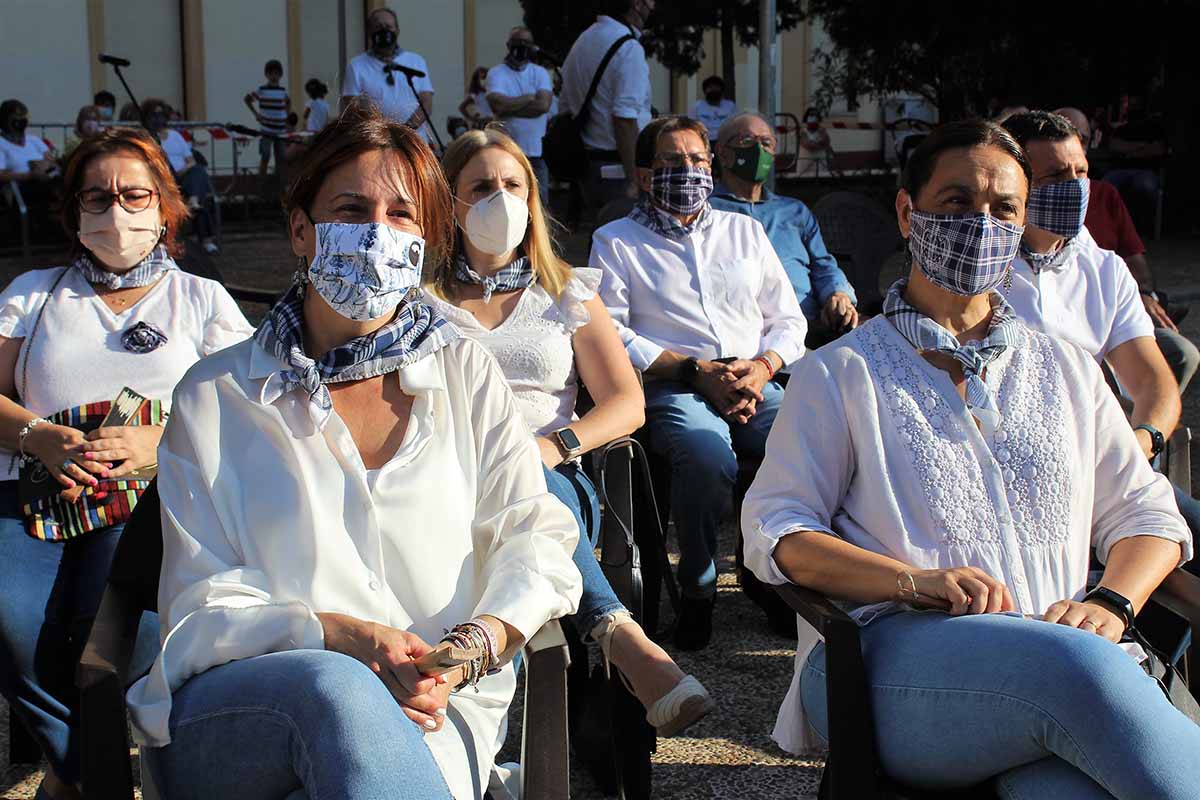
[0,130,253,798]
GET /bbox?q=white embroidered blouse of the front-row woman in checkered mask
[742,317,1192,752]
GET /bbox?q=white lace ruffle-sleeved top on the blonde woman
[425,267,601,437]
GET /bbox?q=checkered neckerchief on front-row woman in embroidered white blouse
[883,278,1021,434]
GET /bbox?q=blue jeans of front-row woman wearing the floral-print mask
[142,650,450,800]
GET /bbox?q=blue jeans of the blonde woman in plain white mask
[542,463,625,639]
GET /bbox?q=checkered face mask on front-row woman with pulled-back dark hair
[908,209,1025,296]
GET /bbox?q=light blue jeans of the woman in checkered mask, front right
[800,612,1200,800]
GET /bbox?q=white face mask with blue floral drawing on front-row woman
[308,222,425,321]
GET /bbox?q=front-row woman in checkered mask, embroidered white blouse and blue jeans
[742,122,1200,800]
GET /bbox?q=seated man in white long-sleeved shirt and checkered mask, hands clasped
[590,116,808,650]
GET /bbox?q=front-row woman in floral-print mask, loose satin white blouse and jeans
[130,106,580,800]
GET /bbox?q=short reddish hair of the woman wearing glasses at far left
[61,128,187,257]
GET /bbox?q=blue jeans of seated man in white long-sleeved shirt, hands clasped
[646,381,784,597]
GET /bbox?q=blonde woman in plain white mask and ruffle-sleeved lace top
[430,128,715,736]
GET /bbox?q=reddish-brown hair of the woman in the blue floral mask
[283,101,454,265]
